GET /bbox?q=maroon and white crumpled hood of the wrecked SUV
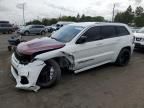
[17,37,65,55]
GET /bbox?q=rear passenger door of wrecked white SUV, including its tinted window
[100,25,121,61]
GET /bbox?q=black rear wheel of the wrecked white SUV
[115,48,131,66]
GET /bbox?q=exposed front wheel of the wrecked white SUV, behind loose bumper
[37,60,61,88]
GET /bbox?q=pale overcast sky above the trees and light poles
[0,0,144,24]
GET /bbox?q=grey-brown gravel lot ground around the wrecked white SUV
[0,35,144,108]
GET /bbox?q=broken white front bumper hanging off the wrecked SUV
[11,54,46,92]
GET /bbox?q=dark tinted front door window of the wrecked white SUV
[83,27,101,42]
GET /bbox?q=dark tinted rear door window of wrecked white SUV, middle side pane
[101,26,117,38]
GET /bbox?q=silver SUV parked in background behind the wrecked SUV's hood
[17,25,46,36]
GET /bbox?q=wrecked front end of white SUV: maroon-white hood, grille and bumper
[11,37,65,91]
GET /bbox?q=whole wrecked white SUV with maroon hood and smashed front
[11,22,134,91]
